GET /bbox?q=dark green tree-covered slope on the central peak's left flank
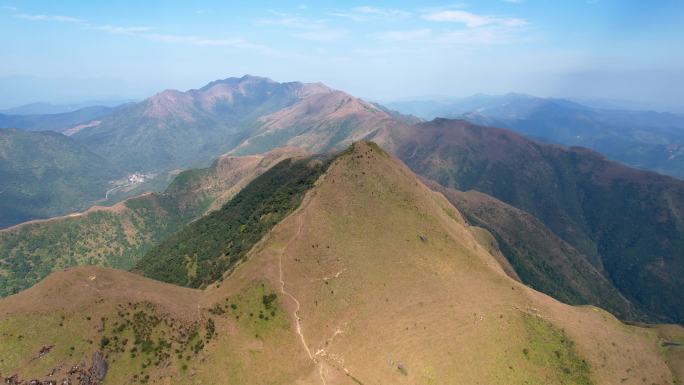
[136,154,334,287]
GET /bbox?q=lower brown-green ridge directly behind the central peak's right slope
[429,182,647,320]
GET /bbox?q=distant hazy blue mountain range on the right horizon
[388,93,684,179]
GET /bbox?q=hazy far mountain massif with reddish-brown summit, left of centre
[73,76,396,171]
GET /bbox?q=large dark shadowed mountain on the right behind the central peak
[397,119,684,322]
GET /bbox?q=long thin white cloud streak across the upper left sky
[8,9,277,54]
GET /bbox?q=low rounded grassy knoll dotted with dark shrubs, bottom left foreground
[0,266,307,385]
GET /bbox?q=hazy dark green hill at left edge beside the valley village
[0,128,123,228]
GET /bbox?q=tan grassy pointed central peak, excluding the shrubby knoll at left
[235,144,672,384]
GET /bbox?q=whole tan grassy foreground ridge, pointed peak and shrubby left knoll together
[0,143,681,384]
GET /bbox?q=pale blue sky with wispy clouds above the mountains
[0,0,684,108]
